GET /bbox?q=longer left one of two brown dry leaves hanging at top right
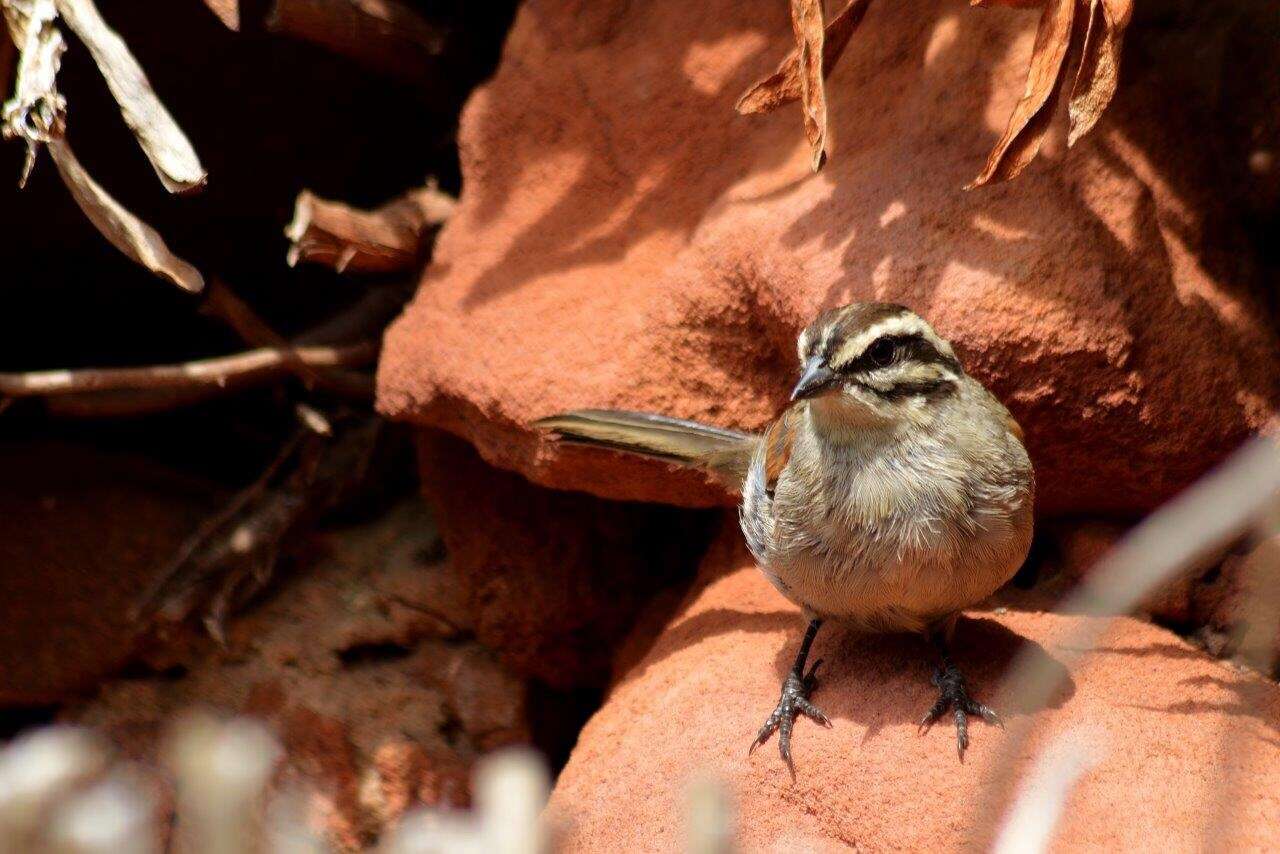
[965,0,1076,189]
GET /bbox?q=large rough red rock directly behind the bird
[379,0,1280,513]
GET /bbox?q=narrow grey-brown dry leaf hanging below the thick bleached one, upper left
[47,137,205,293]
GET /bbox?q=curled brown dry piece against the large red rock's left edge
[284,182,457,273]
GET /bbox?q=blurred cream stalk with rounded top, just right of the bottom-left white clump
[168,716,280,854]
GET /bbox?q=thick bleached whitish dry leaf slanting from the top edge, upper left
[56,0,207,193]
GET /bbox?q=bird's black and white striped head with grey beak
[791,302,964,415]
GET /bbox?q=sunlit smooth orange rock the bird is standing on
[549,531,1280,851]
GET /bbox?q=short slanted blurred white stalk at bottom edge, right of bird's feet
[992,731,1102,854]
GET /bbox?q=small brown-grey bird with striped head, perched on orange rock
[535,302,1036,776]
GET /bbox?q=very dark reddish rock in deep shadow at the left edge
[0,442,219,705]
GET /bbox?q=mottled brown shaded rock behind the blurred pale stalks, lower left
[65,502,530,850]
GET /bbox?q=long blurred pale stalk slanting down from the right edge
[984,437,1280,850]
